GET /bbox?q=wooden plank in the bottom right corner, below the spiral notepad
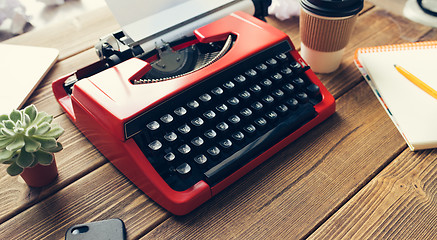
[309,150,437,239]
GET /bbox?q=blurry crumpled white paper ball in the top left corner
[0,0,29,34]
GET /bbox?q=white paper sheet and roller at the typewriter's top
[106,0,255,52]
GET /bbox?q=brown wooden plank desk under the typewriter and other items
[0,2,437,239]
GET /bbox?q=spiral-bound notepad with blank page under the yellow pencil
[354,41,437,151]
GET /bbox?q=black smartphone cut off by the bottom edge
[65,218,126,240]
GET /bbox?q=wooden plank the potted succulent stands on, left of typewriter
[0,115,107,223]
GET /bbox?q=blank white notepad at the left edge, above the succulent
[0,44,59,114]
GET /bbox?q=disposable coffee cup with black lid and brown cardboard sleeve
[300,0,364,73]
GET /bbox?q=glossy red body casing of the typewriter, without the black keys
[52,12,335,215]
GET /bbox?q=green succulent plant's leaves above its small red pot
[0,105,64,176]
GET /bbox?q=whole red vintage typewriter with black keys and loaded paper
[52,0,335,215]
